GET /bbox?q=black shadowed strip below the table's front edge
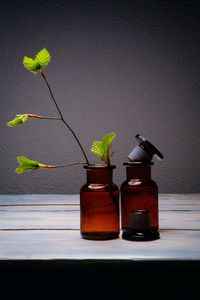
[0,261,200,300]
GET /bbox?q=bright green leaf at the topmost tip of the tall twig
[23,48,51,73]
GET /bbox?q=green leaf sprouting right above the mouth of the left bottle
[91,132,116,165]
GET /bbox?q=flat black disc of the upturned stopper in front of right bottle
[122,230,160,241]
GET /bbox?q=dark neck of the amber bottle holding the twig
[86,168,113,184]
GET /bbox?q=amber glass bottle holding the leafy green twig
[80,165,119,240]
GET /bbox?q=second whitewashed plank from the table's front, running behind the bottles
[0,210,200,230]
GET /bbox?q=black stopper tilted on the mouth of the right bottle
[128,134,164,162]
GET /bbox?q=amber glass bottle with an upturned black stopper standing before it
[121,162,159,241]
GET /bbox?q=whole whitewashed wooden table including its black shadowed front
[0,194,200,300]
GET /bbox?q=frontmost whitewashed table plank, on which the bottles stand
[0,230,200,261]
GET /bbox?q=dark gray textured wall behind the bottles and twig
[0,0,200,194]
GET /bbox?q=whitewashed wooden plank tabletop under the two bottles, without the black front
[0,194,200,263]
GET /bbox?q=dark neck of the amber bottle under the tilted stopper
[126,165,151,180]
